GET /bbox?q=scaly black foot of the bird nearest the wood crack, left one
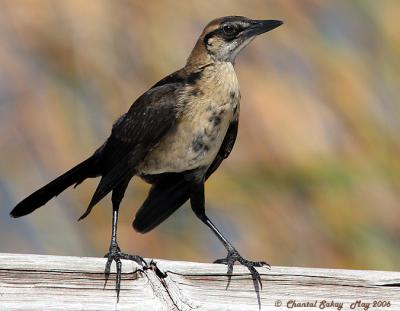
[104,244,147,301]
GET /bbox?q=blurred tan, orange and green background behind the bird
[0,0,400,270]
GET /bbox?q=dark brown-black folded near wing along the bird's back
[81,83,181,218]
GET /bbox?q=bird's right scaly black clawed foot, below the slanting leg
[214,249,271,288]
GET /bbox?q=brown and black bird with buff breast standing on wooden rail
[10,16,283,299]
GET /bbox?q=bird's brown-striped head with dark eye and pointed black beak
[189,16,283,63]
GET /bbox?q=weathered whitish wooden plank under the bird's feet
[0,254,400,311]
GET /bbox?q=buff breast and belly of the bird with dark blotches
[139,64,240,175]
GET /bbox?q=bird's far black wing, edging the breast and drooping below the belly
[133,120,238,233]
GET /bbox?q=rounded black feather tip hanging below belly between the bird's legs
[133,174,190,233]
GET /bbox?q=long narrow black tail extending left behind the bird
[10,154,98,217]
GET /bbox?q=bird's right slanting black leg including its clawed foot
[190,183,270,287]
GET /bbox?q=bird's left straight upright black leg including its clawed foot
[104,179,147,300]
